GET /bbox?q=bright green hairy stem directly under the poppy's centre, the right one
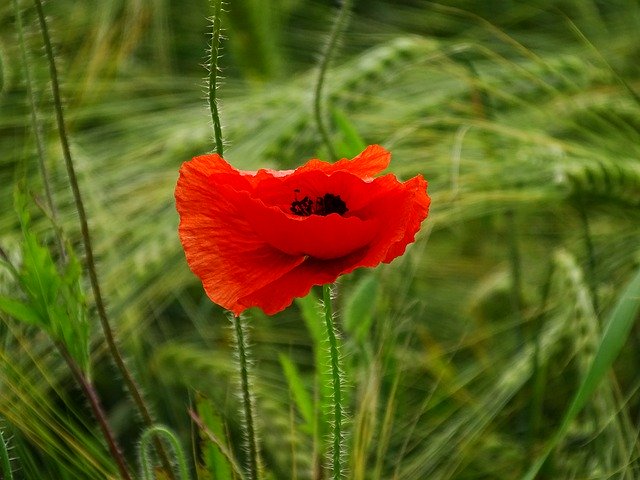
[322,285,343,480]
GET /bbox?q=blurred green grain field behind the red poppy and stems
[0,0,640,480]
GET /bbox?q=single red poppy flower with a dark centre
[175,145,430,315]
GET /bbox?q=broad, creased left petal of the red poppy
[175,157,304,315]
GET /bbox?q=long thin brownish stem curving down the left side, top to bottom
[34,0,175,479]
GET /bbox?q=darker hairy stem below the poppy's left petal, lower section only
[233,315,258,480]
